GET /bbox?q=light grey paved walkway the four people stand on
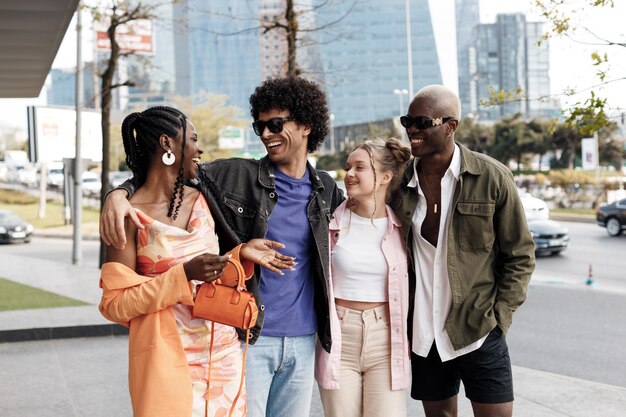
[0,228,626,417]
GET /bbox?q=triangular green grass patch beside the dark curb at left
[0,278,87,311]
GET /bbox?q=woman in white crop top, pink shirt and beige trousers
[315,138,411,417]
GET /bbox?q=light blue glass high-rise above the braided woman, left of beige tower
[173,0,264,117]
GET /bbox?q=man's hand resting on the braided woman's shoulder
[100,190,144,250]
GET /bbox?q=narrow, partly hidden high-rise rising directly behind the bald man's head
[455,0,480,116]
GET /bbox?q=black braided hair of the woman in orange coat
[122,106,187,220]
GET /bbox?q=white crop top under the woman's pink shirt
[331,211,389,302]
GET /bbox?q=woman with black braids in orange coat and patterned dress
[100,107,295,417]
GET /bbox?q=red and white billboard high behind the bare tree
[94,19,154,55]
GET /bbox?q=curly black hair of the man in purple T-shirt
[250,76,330,152]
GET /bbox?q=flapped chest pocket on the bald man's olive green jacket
[456,202,496,251]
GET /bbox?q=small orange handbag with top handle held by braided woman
[193,255,259,330]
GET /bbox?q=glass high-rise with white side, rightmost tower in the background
[475,13,558,121]
